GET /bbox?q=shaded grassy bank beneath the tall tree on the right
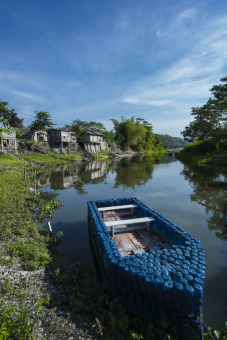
[176,141,227,167]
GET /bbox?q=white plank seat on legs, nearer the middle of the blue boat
[105,217,154,237]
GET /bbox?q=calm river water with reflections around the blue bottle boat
[39,156,227,327]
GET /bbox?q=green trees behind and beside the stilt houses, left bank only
[0,101,162,151]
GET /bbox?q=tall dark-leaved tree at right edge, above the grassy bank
[181,77,227,143]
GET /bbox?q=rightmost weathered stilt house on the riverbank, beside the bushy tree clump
[83,131,108,153]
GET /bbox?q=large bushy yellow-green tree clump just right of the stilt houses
[111,117,161,151]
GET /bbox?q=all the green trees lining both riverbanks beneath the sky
[0,77,227,151]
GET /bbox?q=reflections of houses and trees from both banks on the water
[38,156,227,240]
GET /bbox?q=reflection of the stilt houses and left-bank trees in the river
[38,156,163,195]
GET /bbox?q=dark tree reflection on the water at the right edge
[182,165,227,240]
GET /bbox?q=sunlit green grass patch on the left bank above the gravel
[0,170,50,269]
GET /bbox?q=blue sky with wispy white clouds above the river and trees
[0,0,227,136]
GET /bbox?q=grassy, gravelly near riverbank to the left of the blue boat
[0,155,227,340]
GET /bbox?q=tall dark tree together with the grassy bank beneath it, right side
[178,77,227,168]
